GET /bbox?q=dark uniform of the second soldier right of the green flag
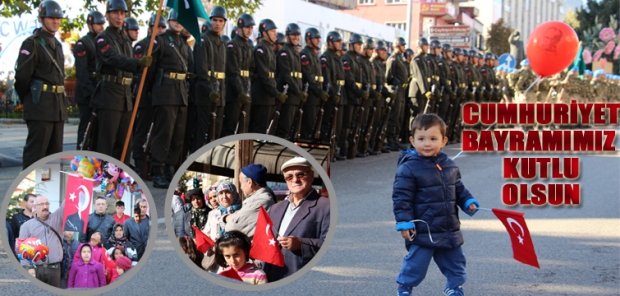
[222,35,254,137]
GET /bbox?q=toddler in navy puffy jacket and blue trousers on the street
[392,114,480,295]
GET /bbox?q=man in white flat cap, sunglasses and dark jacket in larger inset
[264,157,330,283]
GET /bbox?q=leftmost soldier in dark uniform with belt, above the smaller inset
[15,0,69,169]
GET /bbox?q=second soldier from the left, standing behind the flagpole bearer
[73,11,105,150]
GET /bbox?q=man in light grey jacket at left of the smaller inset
[19,195,65,288]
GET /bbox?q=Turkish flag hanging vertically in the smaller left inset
[63,175,94,234]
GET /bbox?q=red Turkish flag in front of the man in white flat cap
[250,207,284,267]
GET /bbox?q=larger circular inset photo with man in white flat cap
[166,134,337,291]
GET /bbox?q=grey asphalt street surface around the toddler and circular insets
[0,122,620,295]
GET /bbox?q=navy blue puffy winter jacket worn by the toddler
[392,149,478,249]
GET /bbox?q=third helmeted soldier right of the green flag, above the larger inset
[250,19,287,134]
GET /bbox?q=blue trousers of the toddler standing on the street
[396,245,467,289]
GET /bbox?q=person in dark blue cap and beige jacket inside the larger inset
[222,164,276,240]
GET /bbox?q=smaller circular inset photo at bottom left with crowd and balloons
[0,151,157,295]
